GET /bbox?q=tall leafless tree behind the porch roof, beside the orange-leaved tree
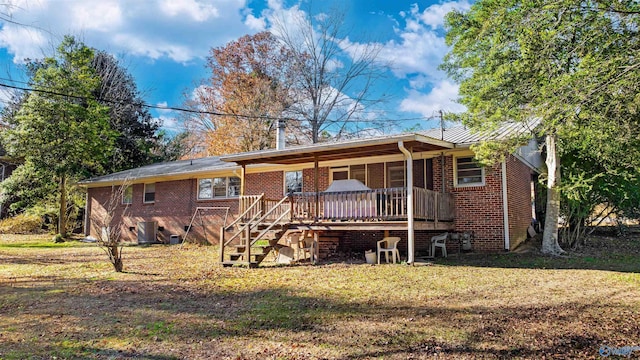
[273,5,388,143]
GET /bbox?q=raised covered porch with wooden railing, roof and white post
[222,134,455,264]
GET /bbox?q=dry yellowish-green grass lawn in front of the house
[0,235,640,359]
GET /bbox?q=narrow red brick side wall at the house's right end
[506,156,532,250]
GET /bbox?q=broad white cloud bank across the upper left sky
[0,0,255,63]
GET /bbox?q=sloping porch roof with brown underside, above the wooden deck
[220,134,455,165]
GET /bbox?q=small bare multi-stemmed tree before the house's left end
[89,181,130,272]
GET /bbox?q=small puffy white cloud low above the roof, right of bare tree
[400,80,465,117]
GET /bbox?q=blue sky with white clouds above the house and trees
[0,0,469,135]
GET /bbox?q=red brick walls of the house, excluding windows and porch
[89,156,531,256]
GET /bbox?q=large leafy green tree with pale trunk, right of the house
[442,0,640,253]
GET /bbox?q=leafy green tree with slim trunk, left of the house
[4,37,117,236]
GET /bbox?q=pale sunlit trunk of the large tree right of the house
[542,134,564,255]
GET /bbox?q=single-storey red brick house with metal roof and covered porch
[81,124,542,263]
